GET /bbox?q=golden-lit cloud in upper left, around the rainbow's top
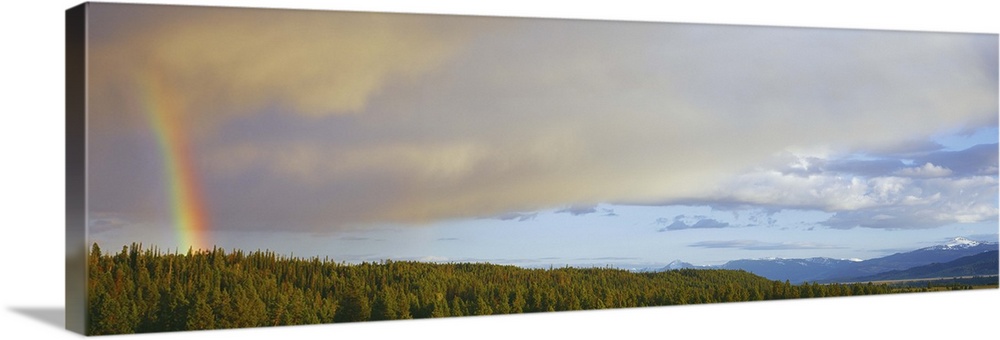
[88,5,489,134]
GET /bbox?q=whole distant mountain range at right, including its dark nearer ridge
[645,237,998,283]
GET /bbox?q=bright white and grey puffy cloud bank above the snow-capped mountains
[704,163,998,229]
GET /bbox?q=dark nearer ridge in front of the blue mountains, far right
[844,250,1000,281]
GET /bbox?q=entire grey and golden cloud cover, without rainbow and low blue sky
[88,5,998,235]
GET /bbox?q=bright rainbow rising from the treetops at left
[140,72,210,251]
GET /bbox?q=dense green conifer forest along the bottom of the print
[87,243,927,335]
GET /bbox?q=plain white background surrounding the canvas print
[0,0,1000,339]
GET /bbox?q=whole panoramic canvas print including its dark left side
[67,3,998,335]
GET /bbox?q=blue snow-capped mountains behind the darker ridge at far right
[658,237,997,283]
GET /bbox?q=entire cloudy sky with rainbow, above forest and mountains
[87,4,998,268]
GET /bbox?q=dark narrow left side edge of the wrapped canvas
[65,3,89,334]
